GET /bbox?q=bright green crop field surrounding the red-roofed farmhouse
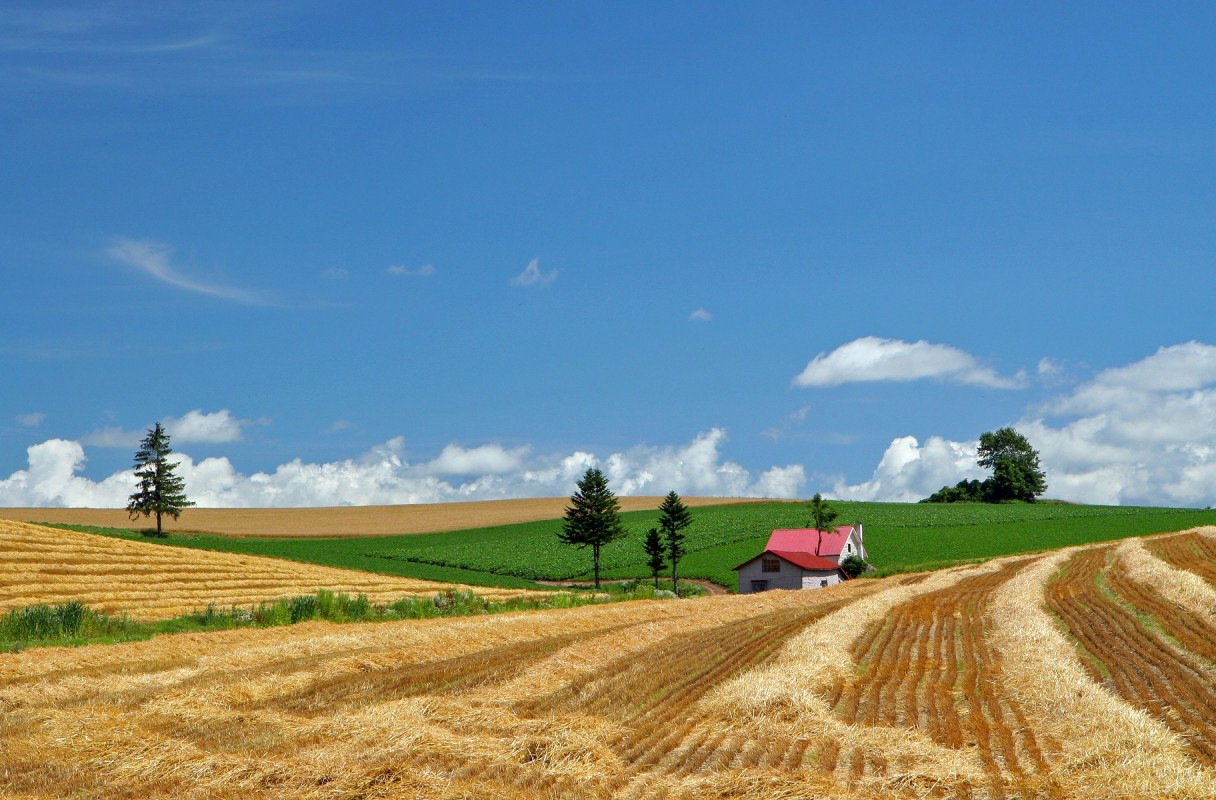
[38,501,1216,588]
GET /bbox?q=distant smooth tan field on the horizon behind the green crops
[0,497,773,537]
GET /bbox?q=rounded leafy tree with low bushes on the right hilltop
[921,428,1047,503]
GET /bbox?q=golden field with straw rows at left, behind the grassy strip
[0,520,532,620]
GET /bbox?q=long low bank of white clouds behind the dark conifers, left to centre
[0,428,805,508]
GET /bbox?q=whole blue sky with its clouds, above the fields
[0,2,1216,506]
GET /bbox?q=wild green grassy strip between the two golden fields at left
[0,581,685,653]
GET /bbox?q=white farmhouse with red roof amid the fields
[734,523,868,595]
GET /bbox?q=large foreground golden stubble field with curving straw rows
[7,529,1216,800]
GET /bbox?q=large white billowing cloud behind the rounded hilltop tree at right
[835,342,1216,506]
